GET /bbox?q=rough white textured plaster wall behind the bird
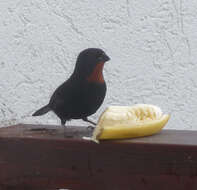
[0,0,197,129]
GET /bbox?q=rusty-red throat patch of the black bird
[87,63,104,83]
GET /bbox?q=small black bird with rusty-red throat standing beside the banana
[33,48,110,125]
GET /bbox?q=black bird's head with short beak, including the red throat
[74,48,110,80]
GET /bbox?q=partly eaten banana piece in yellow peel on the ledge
[91,104,170,143]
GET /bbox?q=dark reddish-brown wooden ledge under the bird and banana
[0,124,197,190]
